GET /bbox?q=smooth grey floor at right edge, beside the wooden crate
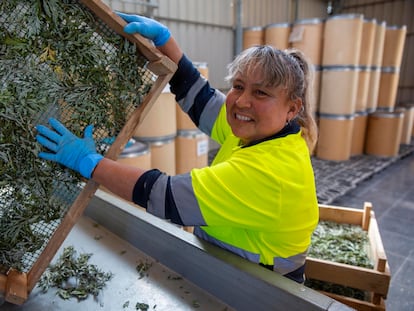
[332,153,414,311]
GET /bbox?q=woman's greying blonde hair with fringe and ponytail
[226,45,318,152]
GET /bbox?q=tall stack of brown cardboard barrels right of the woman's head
[243,14,414,161]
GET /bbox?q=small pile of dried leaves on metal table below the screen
[39,246,113,300]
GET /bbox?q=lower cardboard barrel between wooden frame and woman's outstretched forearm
[117,139,151,170]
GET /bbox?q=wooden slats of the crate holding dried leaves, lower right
[306,202,391,311]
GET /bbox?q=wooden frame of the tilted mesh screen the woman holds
[0,0,177,305]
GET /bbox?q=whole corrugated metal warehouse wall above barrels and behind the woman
[104,0,414,102]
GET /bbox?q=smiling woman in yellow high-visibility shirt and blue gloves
[37,13,318,283]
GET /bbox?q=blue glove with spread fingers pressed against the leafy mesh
[36,118,103,178]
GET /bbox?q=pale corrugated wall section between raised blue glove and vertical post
[155,0,234,89]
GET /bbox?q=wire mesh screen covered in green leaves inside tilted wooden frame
[0,0,156,274]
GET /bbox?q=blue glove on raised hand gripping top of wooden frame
[116,12,171,46]
